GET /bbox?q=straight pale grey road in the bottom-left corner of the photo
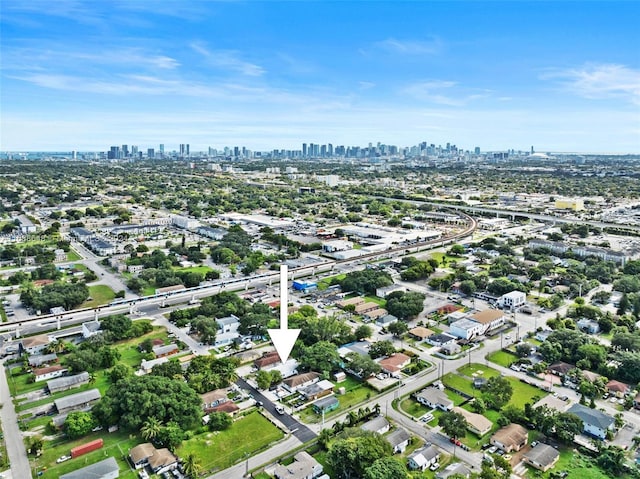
[0,361,32,479]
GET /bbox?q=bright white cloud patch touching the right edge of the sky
[541,63,640,105]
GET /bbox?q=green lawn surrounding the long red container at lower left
[36,430,139,479]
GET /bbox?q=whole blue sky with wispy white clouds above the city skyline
[0,0,640,153]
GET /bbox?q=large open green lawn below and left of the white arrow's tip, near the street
[176,412,284,472]
